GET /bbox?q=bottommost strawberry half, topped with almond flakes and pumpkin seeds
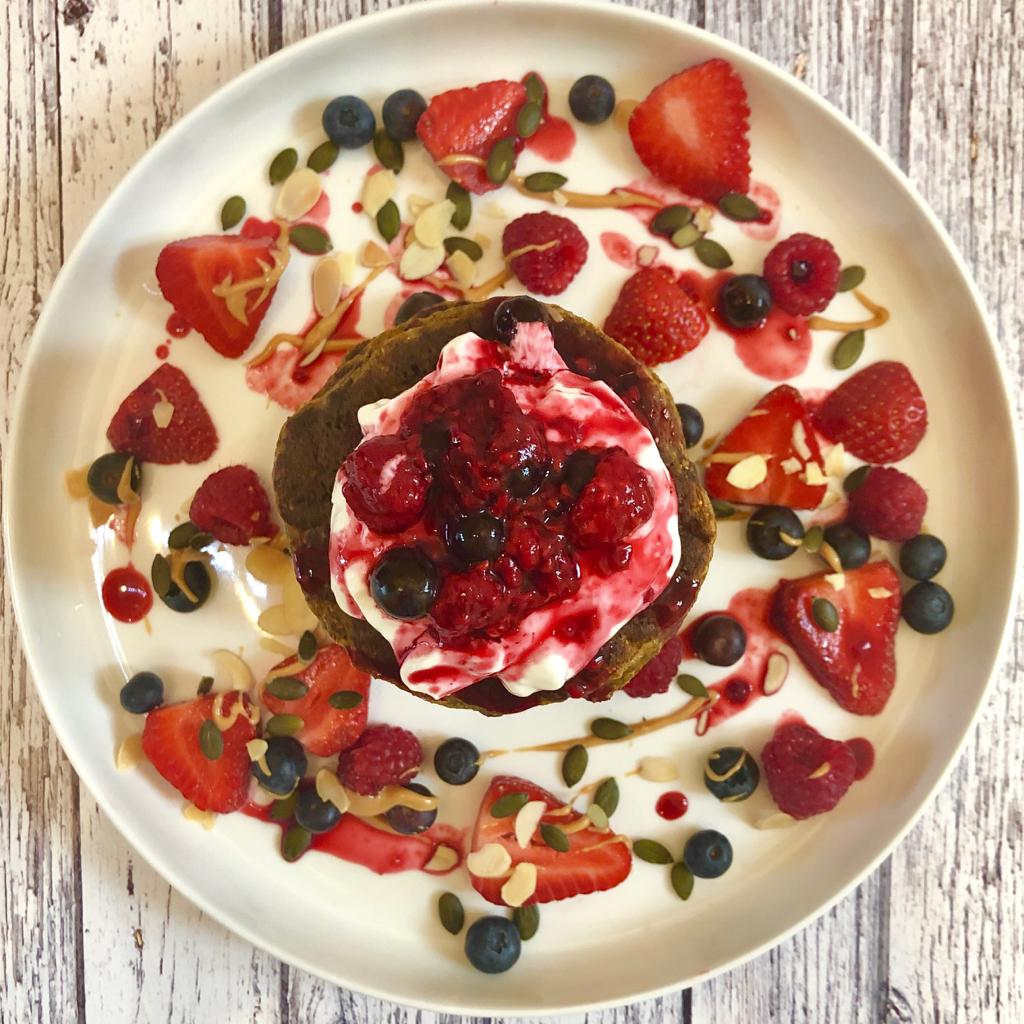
[470,775,633,905]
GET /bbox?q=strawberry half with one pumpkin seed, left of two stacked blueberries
[771,561,900,715]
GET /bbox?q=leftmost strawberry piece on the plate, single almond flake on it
[106,362,217,465]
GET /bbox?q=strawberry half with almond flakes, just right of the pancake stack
[705,384,826,509]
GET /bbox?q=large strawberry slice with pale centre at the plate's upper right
[630,57,751,203]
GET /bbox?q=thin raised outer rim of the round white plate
[2,0,1024,1018]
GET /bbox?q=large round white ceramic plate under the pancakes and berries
[5,0,1018,1015]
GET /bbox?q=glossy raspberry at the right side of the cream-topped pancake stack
[568,447,654,548]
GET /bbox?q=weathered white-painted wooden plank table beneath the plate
[0,0,1024,1024]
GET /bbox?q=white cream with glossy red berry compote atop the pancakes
[330,323,679,697]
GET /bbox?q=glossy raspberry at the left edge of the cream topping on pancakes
[342,434,430,534]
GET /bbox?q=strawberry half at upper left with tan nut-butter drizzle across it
[157,234,278,359]
